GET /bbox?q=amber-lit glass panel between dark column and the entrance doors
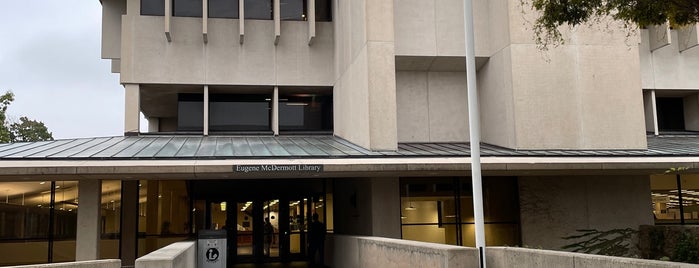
[138,180,191,256]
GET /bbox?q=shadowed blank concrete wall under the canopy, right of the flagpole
[519,176,653,250]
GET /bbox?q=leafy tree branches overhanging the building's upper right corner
[520,0,699,48]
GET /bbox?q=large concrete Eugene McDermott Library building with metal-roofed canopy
[0,0,699,265]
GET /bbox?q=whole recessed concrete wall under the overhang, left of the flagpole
[396,72,468,142]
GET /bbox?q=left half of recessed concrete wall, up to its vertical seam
[396,72,430,142]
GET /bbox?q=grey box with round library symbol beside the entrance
[197,230,227,268]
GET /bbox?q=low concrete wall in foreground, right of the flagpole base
[486,247,699,268]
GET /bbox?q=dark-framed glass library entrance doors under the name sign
[192,179,328,265]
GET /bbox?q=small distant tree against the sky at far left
[0,91,53,143]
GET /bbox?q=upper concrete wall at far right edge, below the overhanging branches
[639,29,699,90]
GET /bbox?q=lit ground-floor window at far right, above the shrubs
[650,174,699,224]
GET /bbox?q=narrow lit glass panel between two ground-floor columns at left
[100,180,121,259]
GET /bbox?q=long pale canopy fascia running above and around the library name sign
[0,157,699,180]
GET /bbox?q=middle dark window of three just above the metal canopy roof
[209,94,272,131]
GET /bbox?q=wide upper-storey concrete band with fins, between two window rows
[121,16,334,86]
